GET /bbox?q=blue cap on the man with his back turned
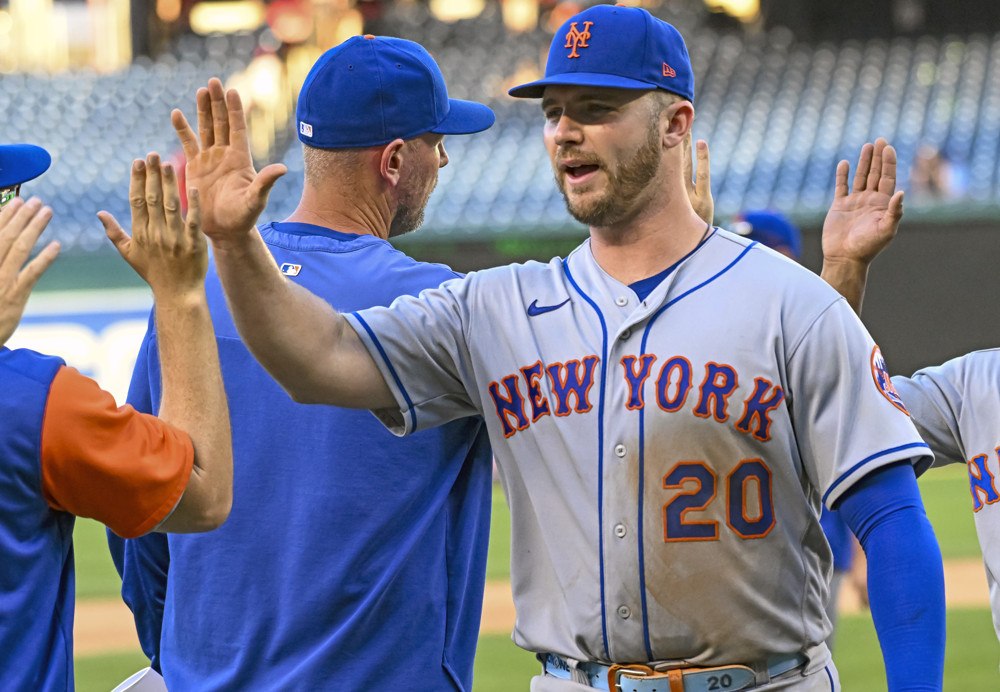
[295,35,496,149]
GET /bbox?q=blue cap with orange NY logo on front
[507,5,694,101]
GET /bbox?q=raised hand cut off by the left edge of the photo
[0,198,59,346]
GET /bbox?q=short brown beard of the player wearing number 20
[556,122,660,227]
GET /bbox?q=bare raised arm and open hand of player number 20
[171,79,395,408]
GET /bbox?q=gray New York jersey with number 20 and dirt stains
[349,230,930,665]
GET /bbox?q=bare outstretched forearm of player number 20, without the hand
[213,230,395,408]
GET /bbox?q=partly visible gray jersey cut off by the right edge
[892,349,1000,639]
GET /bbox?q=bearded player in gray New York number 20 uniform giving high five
[172,5,944,692]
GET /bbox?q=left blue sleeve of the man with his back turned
[107,316,170,672]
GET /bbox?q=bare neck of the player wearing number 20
[590,206,707,285]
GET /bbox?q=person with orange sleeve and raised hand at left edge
[0,145,232,691]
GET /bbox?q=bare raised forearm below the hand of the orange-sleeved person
[154,284,233,532]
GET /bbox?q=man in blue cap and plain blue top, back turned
[110,35,494,692]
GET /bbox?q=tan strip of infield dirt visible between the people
[73,559,989,656]
